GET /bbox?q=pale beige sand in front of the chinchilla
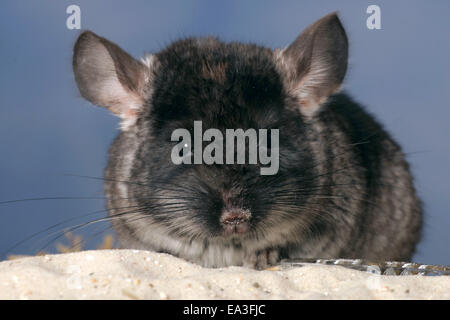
[0,250,450,299]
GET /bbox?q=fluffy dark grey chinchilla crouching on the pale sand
[73,13,422,268]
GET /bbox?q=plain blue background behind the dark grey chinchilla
[0,0,450,265]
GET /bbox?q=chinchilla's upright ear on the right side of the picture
[278,13,348,115]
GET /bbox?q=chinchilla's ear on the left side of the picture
[73,31,154,130]
